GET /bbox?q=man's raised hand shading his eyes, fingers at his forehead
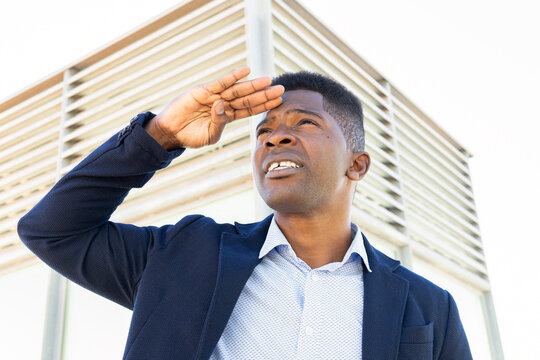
[145,67,285,150]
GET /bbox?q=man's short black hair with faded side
[272,71,365,152]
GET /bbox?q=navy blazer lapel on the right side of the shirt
[362,233,409,360]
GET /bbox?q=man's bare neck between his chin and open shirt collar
[274,211,352,269]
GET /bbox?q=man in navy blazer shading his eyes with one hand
[19,68,471,360]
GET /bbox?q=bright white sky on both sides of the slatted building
[0,0,540,359]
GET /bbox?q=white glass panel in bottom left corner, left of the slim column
[0,263,50,359]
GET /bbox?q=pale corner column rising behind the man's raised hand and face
[244,0,275,220]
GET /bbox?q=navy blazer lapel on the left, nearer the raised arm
[198,216,272,359]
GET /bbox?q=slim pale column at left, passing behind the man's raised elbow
[41,69,76,360]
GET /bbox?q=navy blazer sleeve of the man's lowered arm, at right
[439,292,472,360]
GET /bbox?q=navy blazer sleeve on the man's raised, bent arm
[17,112,183,309]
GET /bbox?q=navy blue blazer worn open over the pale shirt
[18,113,472,360]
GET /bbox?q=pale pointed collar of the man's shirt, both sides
[259,217,371,272]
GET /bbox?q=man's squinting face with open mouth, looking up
[253,90,353,214]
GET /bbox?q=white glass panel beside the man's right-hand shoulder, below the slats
[414,258,491,359]
